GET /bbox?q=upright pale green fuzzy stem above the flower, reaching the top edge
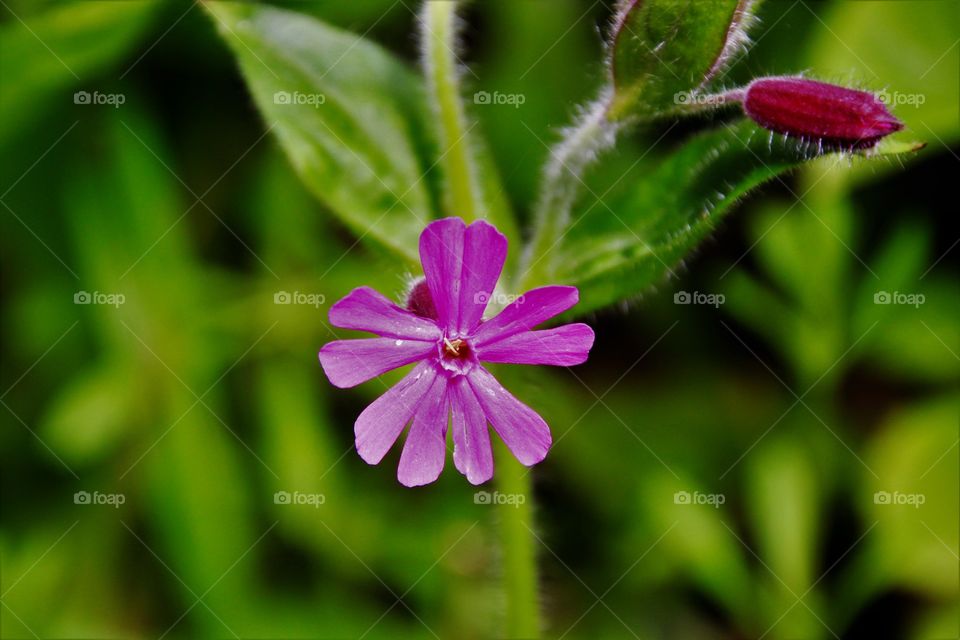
[421,0,482,221]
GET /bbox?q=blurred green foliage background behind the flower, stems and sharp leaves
[0,0,960,639]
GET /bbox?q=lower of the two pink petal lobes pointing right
[477,323,594,367]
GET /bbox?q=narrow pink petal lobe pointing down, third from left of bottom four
[447,376,493,484]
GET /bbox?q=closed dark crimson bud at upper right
[743,78,903,149]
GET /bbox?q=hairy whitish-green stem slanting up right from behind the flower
[518,89,618,291]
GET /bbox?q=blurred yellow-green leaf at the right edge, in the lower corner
[833,394,960,628]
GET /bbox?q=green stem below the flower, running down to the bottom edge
[496,443,540,638]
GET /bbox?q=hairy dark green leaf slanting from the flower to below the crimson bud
[544,121,912,313]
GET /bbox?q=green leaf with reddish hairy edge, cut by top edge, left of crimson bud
[609,0,756,120]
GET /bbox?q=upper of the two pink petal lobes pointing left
[330,287,440,340]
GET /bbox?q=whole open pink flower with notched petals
[320,218,593,487]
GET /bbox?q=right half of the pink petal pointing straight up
[458,220,507,334]
